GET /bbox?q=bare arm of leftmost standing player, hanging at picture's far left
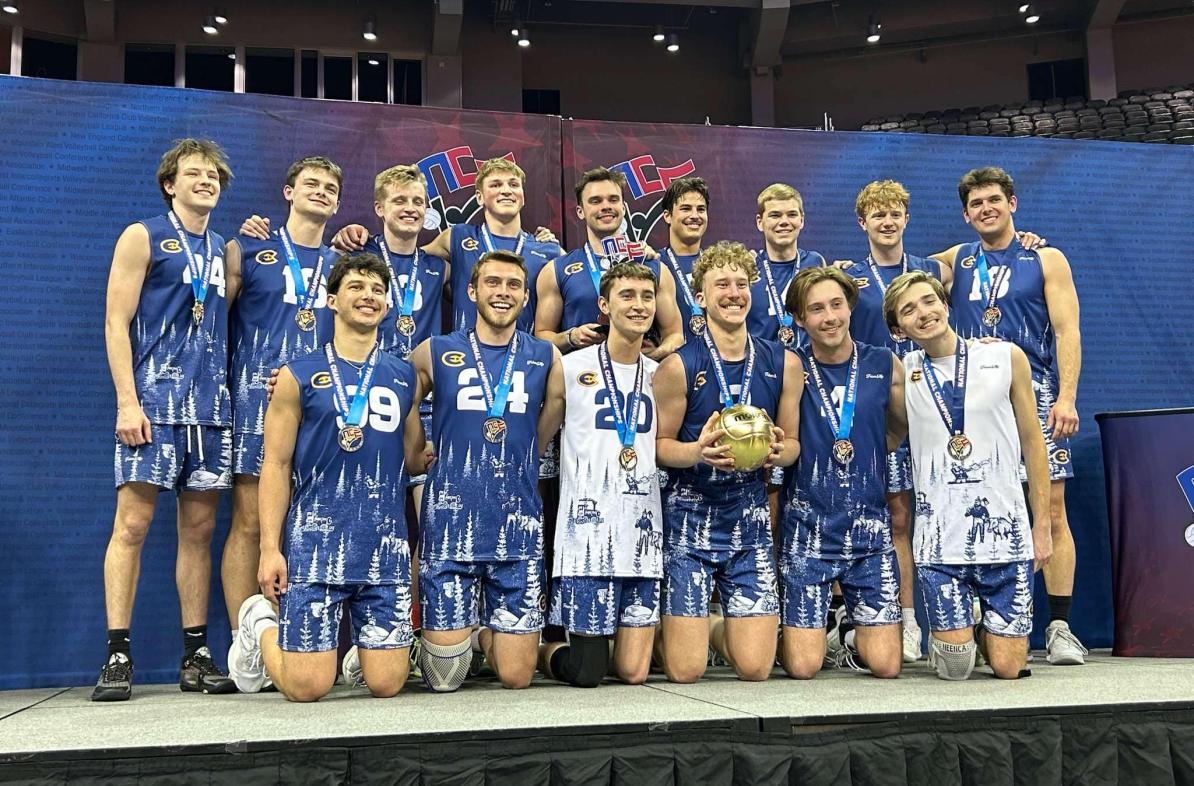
[104,223,152,447]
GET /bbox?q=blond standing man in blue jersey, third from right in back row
[746,183,825,349]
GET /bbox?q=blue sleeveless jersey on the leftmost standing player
[129,215,232,425]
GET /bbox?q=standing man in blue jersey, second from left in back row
[220,155,343,635]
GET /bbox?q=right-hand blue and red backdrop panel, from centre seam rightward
[564,121,1194,646]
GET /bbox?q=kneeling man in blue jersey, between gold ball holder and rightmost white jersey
[780,266,907,680]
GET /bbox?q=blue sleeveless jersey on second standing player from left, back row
[229,232,336,434]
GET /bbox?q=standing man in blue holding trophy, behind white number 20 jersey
[535,166,684,361]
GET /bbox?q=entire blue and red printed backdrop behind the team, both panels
[0,76,1194,689]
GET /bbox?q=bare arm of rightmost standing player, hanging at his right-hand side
[1040,248,1082,440]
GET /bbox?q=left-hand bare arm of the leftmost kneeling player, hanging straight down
[257,367,302,603]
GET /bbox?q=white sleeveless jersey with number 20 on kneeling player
[553,345,663,577]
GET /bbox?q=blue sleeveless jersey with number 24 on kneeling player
[421,331,553,561]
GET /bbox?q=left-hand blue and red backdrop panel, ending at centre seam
[0,76,560,688]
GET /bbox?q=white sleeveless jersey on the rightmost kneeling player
[904,342,1033,565]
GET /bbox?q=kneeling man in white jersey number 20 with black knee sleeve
[540,263,663,688]
